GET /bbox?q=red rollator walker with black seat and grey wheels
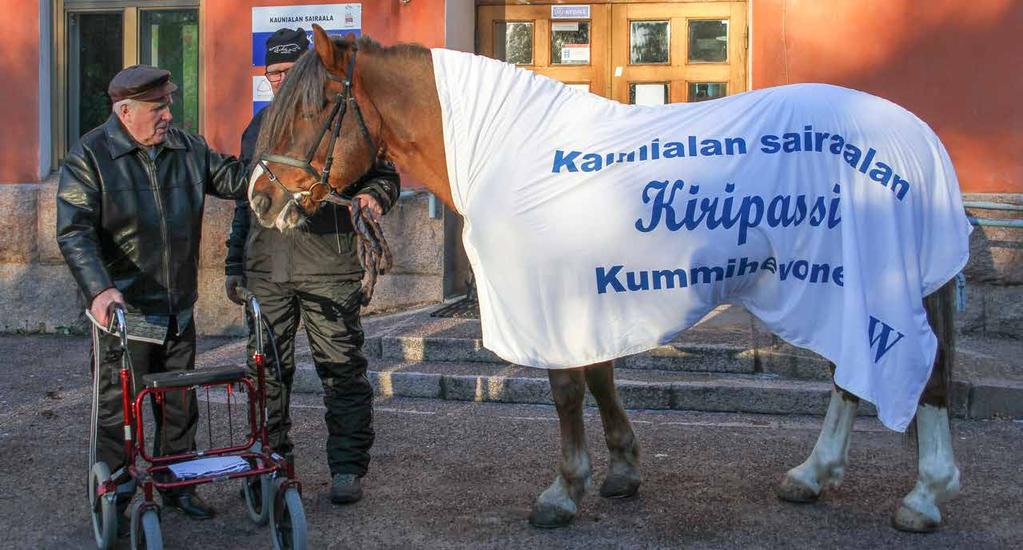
[89,288,307,550]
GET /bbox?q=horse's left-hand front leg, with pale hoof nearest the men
[529,368,592,529]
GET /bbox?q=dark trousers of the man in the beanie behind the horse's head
[247,277,373,475]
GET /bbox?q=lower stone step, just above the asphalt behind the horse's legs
[294,359,876,415]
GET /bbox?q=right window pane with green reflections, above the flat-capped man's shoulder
[138,9,198,132]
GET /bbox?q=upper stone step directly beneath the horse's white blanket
[360,335,831,381]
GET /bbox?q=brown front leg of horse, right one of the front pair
[585,361,642,499]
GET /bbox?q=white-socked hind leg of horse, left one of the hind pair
[775,380,859,502]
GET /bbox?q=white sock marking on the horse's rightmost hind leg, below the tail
[896,405,960,528]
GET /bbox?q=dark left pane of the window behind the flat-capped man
[68,12,124,141]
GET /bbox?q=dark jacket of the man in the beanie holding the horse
[224,109,401,283]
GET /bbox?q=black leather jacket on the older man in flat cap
[56,114,247,315]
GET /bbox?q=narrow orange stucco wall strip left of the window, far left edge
[0,0,39,183]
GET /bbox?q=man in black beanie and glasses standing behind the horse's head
[225,29,401,504]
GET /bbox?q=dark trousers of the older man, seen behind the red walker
[92,316,198,475]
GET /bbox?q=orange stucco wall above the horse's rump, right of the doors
[750,0,1023,193]
